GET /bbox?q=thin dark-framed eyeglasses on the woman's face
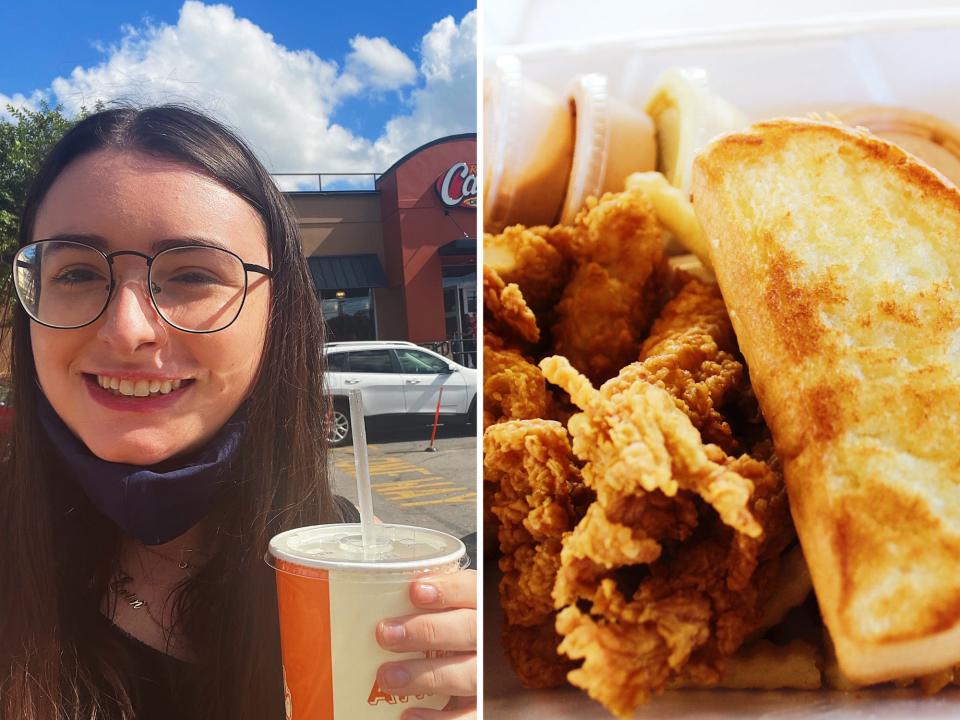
[13,240,273,333]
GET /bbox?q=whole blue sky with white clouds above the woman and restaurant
[0,0,476,180]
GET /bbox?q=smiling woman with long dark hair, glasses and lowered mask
[0,106,476,720]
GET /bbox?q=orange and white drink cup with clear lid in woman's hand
[266,524,466,720]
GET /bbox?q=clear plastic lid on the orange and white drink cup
[265,523,467,572]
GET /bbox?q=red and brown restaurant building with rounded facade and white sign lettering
[286,133,477,367]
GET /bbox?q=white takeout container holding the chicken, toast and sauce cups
[484,8,960,720]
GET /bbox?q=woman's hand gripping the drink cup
[377,570,477,720]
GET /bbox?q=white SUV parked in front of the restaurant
[325,340,477,445]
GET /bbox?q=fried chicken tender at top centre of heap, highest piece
[548,191,666,383]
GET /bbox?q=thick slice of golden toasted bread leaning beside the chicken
[692,120,960,684]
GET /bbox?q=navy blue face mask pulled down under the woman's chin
[37,390,246,545]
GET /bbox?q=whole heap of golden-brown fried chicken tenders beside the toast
[484,191,795,716]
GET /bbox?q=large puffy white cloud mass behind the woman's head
[11,0,476,173]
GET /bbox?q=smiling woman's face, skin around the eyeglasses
[30,150,270,465]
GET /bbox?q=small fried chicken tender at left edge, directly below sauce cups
[483,225,571,309]
